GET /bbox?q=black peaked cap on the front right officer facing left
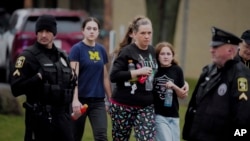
[210,27,242,47]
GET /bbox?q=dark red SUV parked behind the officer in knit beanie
[1,8,87,80]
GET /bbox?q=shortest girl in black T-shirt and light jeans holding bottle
[153,42,188,141]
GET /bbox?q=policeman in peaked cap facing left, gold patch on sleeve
[183,27,250,141]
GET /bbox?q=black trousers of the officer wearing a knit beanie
[24,111,74,141]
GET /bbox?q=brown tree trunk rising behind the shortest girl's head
[146,0,180,45]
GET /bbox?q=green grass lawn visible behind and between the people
[0,79,196,141]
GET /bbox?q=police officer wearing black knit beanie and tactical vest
[10,15,76,141]
